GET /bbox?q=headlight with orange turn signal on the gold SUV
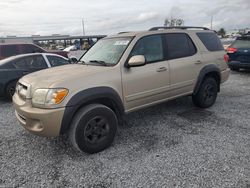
[32,88,69,107]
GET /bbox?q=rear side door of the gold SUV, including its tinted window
[165,33,202,96]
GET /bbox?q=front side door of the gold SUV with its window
[122,34,169,111]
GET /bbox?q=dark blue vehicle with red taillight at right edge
[227,35,250,71]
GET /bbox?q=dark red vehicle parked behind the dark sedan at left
[0,43,68,60]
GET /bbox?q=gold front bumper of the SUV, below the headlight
[13,94,65,137]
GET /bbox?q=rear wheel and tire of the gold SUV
[192,77,219,108]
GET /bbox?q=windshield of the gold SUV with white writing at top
[80,37,132,66]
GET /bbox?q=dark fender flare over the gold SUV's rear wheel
[193,64,221,95]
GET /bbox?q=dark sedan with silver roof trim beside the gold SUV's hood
[0,53,70,99]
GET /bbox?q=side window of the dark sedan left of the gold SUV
[13,55,47,69]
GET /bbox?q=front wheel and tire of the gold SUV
[69,104,118,154]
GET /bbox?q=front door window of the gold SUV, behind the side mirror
[130,35,164,63]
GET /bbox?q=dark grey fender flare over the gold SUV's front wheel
[60,87,124,134]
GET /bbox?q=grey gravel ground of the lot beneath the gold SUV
[0,72,250,188]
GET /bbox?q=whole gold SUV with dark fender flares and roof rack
[13,27,229,153]
